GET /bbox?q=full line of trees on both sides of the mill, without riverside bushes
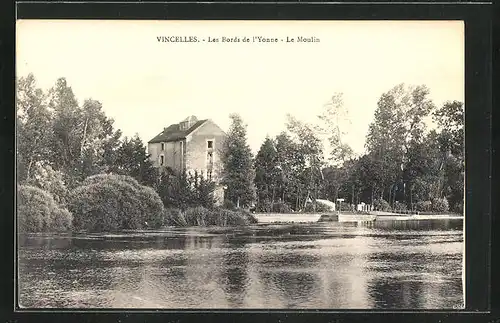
[16,74,464,228]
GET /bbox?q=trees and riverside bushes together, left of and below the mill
[16,74,255,232]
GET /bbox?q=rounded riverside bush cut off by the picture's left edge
[17,185,72,232]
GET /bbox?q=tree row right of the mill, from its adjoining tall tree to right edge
[224,84,465,213]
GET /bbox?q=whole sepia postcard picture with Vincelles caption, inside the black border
[15,19,466,310]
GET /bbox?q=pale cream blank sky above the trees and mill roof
[16,20,465,154]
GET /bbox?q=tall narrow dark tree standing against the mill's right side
[221,114,255,207]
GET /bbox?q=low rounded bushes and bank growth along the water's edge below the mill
[18,174,257,232]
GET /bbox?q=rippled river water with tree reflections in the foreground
[18,220,464,309]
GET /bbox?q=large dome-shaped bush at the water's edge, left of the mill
[68,174,164,231]
